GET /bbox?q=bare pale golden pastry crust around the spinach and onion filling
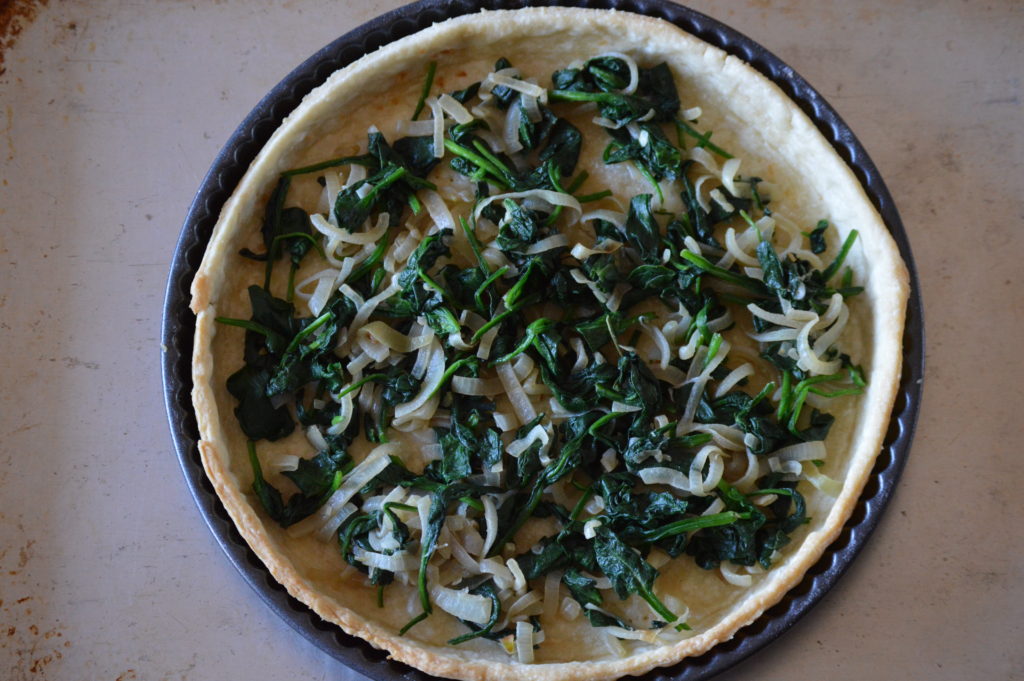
[191,8,907,681]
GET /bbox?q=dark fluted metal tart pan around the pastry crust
[162,0,924,681]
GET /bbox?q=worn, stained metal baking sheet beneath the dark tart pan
[0,0,1024,681]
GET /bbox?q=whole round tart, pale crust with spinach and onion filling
[193,9,906,679]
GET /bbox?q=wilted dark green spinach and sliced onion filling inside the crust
[218,55,865,645]
